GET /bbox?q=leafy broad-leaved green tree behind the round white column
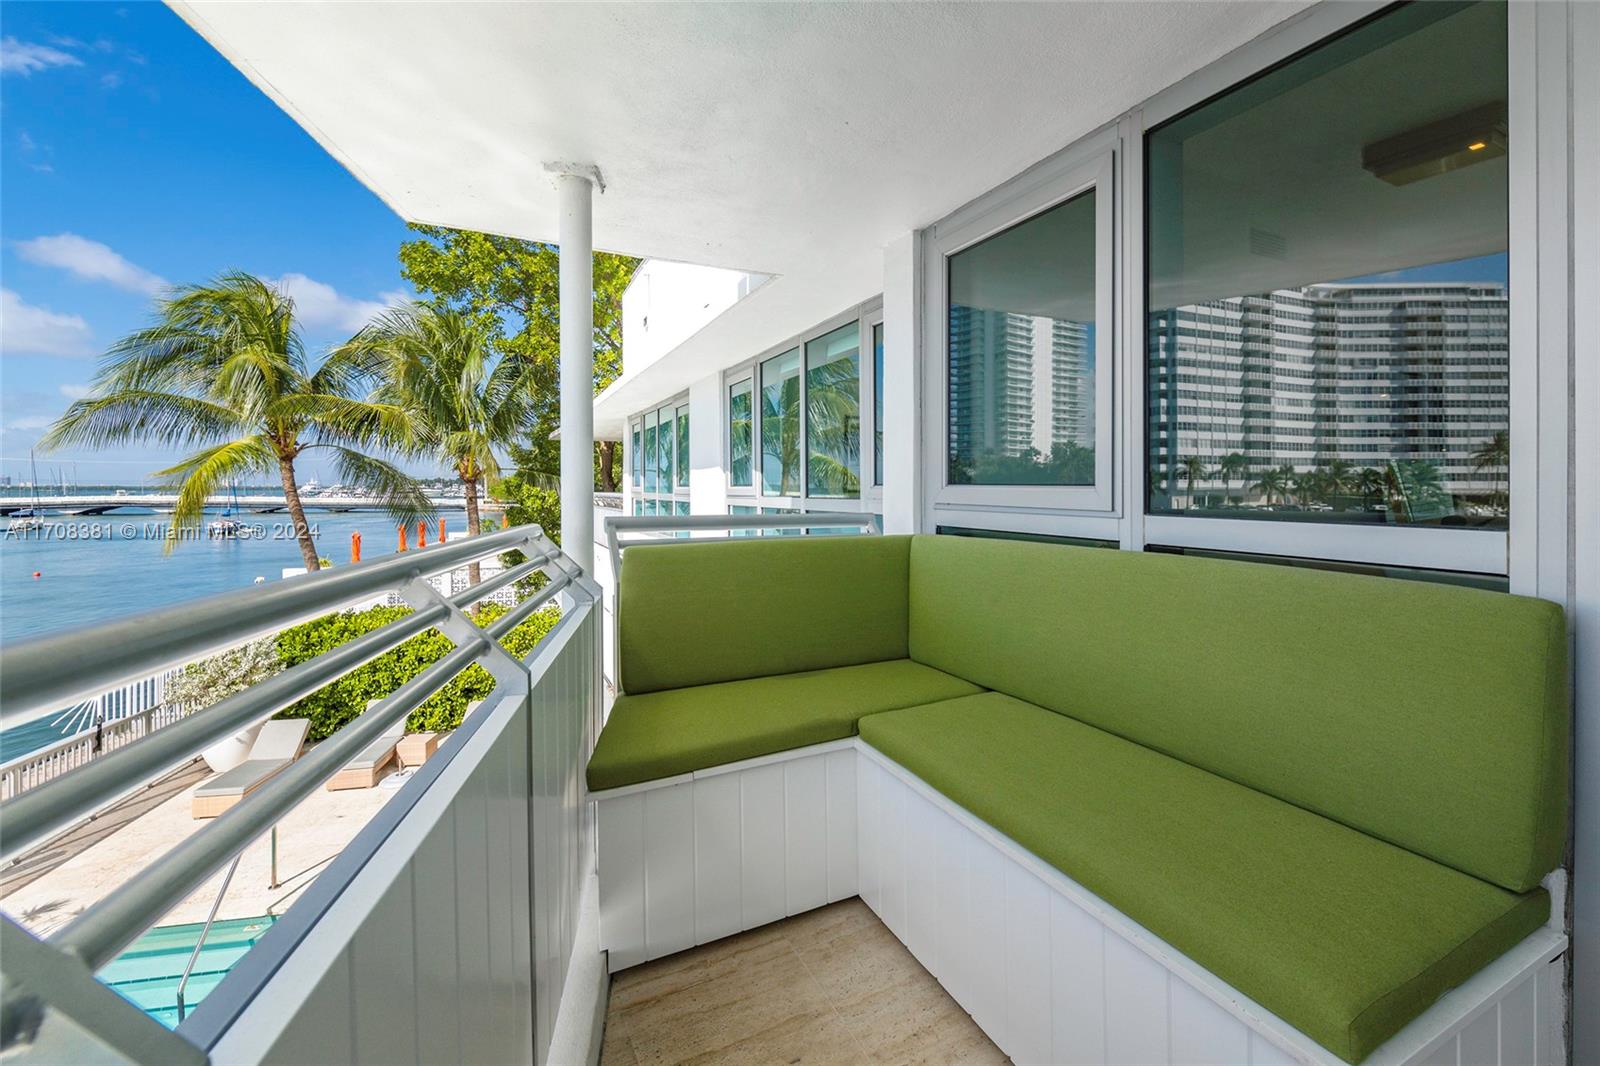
[400,226,638,491]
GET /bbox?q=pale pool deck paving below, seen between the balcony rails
[0,752,398,935]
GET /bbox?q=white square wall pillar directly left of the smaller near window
[883,232,933,533]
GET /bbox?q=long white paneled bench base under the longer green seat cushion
[857,739,1566,1066]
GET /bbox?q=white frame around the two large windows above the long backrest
[920,0,1542,582]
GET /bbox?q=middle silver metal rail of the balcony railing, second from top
[0,527,556,860]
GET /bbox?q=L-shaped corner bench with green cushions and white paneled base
[587,536,1568,1063]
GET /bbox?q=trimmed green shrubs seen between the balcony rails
[278,603,560,741]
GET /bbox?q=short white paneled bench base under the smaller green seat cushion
[589,739,858,973]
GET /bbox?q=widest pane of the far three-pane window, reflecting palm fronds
[805,322,861,496]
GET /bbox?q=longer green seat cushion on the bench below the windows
[861,693,1550,1063]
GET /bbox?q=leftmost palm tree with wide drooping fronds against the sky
[40,274,432,570]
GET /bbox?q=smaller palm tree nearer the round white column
[349,304,533,584]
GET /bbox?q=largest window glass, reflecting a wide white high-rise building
[1146,3,1510,528]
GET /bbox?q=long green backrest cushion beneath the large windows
[910,536,1568,892]
